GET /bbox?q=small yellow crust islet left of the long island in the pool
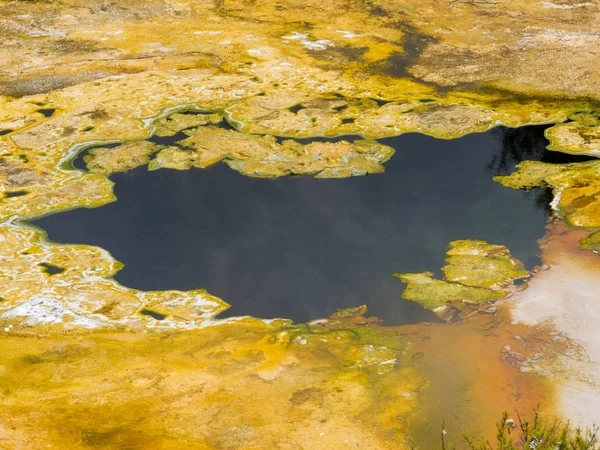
[83,141,164,176]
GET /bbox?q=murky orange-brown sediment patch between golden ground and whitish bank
[401,305,564,449]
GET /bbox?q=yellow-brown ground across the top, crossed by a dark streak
[0,0,598,96]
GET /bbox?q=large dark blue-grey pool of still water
[35,127,549,324]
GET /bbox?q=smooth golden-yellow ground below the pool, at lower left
[0,319,426,449]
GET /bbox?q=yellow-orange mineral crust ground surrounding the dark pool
[0,0,600,449]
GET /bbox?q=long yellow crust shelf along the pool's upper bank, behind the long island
[231,95,515,138]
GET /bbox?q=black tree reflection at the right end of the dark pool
[487,125,593,215]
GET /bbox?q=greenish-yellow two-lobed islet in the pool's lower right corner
[394,240,529,310]
